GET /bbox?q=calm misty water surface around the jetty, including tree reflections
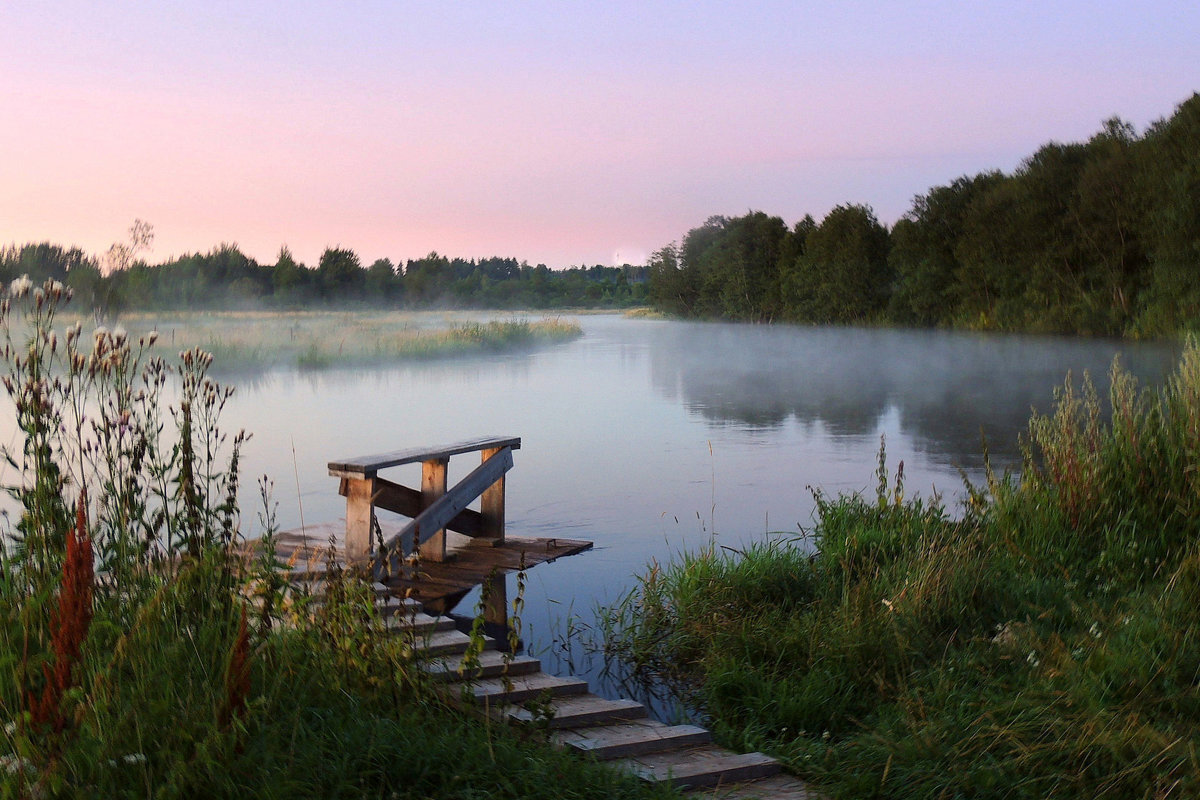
[208,315,1178,686]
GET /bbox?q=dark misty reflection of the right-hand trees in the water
[650,324,1178,465]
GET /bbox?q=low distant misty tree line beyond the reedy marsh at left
[0,239,647,314]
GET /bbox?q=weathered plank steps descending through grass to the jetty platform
[379,585,820,800]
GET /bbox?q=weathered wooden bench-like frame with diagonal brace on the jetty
[329,437,521,578]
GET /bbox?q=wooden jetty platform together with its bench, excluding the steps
[278,437,592,626]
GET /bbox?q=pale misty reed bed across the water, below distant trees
[52,311,581,369]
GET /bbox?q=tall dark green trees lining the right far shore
[649,94,1200,336]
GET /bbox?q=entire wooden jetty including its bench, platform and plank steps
[277,437,818,800]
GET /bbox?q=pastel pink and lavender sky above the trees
[0,0,1200,267]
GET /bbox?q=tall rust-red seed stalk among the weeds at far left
[29,489,95,733]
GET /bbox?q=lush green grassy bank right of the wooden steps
[606,342,1200,799]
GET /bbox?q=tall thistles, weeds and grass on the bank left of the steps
[0,278,678,800]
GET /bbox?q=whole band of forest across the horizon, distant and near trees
[0,94,1200,337]
